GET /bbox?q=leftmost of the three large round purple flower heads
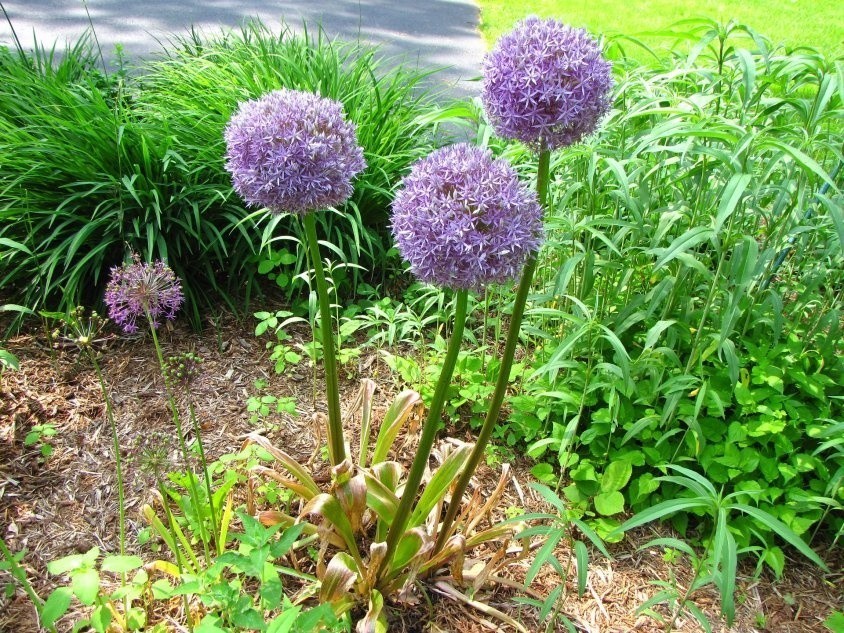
[225,89,366,214]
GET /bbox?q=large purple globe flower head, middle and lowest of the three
[393,143,543,290]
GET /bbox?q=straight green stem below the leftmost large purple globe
[302,213,346,466]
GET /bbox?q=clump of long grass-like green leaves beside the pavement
[0,23,446,322]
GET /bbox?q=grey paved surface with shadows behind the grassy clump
[0,0,484,96]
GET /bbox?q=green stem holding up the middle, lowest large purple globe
[380,290,469,573]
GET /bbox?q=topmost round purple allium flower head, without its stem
[482,16,613,149]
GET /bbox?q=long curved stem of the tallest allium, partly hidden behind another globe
[434,149,551,553]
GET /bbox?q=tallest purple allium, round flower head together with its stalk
[435,17,613,551]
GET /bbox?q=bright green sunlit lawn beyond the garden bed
[478,0,844,56]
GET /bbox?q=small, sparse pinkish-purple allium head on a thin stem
[105,255,185,334]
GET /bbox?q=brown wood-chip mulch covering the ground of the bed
[0,320,844,633]
